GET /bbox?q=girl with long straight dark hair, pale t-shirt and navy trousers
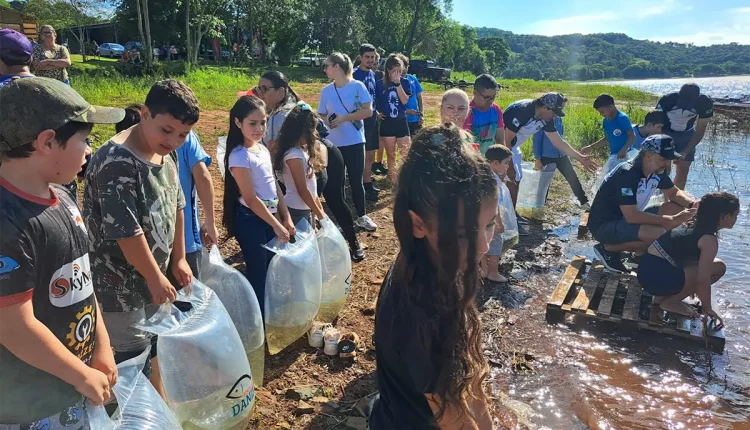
[222,96,295,312]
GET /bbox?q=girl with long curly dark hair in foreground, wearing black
[369,125,498,430]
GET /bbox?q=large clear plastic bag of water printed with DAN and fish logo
[134,280,255,430]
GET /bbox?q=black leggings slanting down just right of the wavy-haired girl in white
[318,145,364,245]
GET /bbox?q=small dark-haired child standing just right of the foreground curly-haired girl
[482,145,513,283]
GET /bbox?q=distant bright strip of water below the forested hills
[584,75,750,97]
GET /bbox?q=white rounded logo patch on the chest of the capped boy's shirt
[49,254,94,308]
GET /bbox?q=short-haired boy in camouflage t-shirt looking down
[83,80,199,393]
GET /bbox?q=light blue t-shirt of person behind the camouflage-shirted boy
[176,131,211,253]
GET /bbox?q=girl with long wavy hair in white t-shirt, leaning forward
[273,102,326,225]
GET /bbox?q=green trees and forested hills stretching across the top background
[11,0,750,80]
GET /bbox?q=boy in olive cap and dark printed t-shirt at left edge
[0,78,124,430]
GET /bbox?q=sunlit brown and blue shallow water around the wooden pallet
[502,127,750,429]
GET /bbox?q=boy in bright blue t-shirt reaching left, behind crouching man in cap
[581,94,635,160]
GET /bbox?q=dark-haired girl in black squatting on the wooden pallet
[638,192,740,328]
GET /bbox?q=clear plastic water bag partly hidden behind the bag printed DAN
[201,245,266,387]
